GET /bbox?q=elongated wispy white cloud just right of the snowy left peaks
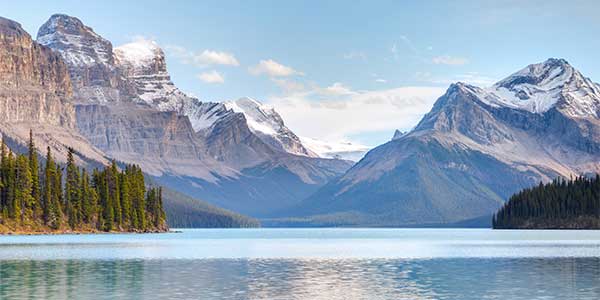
[165,45,240,68]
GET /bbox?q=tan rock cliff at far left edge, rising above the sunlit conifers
[0,17,106,163]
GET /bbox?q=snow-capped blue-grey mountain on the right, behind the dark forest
[289,59,600,226]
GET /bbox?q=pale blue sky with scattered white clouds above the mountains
[0,0,600,146]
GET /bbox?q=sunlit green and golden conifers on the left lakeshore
[0,133,168,233]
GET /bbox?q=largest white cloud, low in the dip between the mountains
[269,84,445,140]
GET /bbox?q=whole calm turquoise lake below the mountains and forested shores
[0,229,600,300]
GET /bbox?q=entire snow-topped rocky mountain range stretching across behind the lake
[0,14,600,226]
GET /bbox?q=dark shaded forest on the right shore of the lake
[492,175,600,229]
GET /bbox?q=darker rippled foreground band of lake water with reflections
[0,258,600,299]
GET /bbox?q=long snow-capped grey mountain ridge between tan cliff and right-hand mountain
[38,14,351,216]
